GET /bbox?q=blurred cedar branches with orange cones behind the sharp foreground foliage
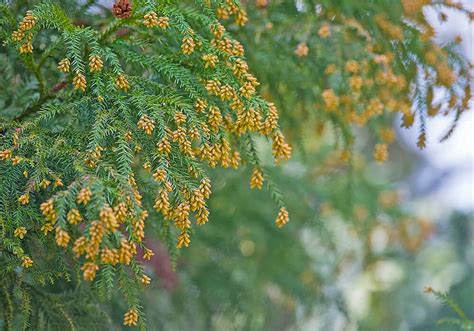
[233,0,473,162]
